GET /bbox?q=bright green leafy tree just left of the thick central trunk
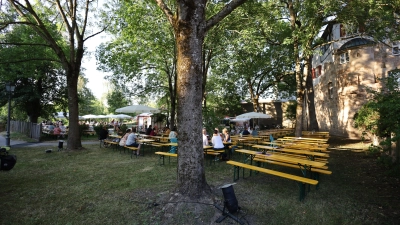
[97,1,177,126]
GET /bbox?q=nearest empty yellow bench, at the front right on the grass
[226,160,318,201]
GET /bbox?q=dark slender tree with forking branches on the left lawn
[0,0,106,149]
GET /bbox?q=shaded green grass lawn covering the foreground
[0,138,400,225]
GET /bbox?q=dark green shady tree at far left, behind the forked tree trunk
[0,22,67,123]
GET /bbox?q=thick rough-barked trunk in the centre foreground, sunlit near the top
[174,1,210,198]
